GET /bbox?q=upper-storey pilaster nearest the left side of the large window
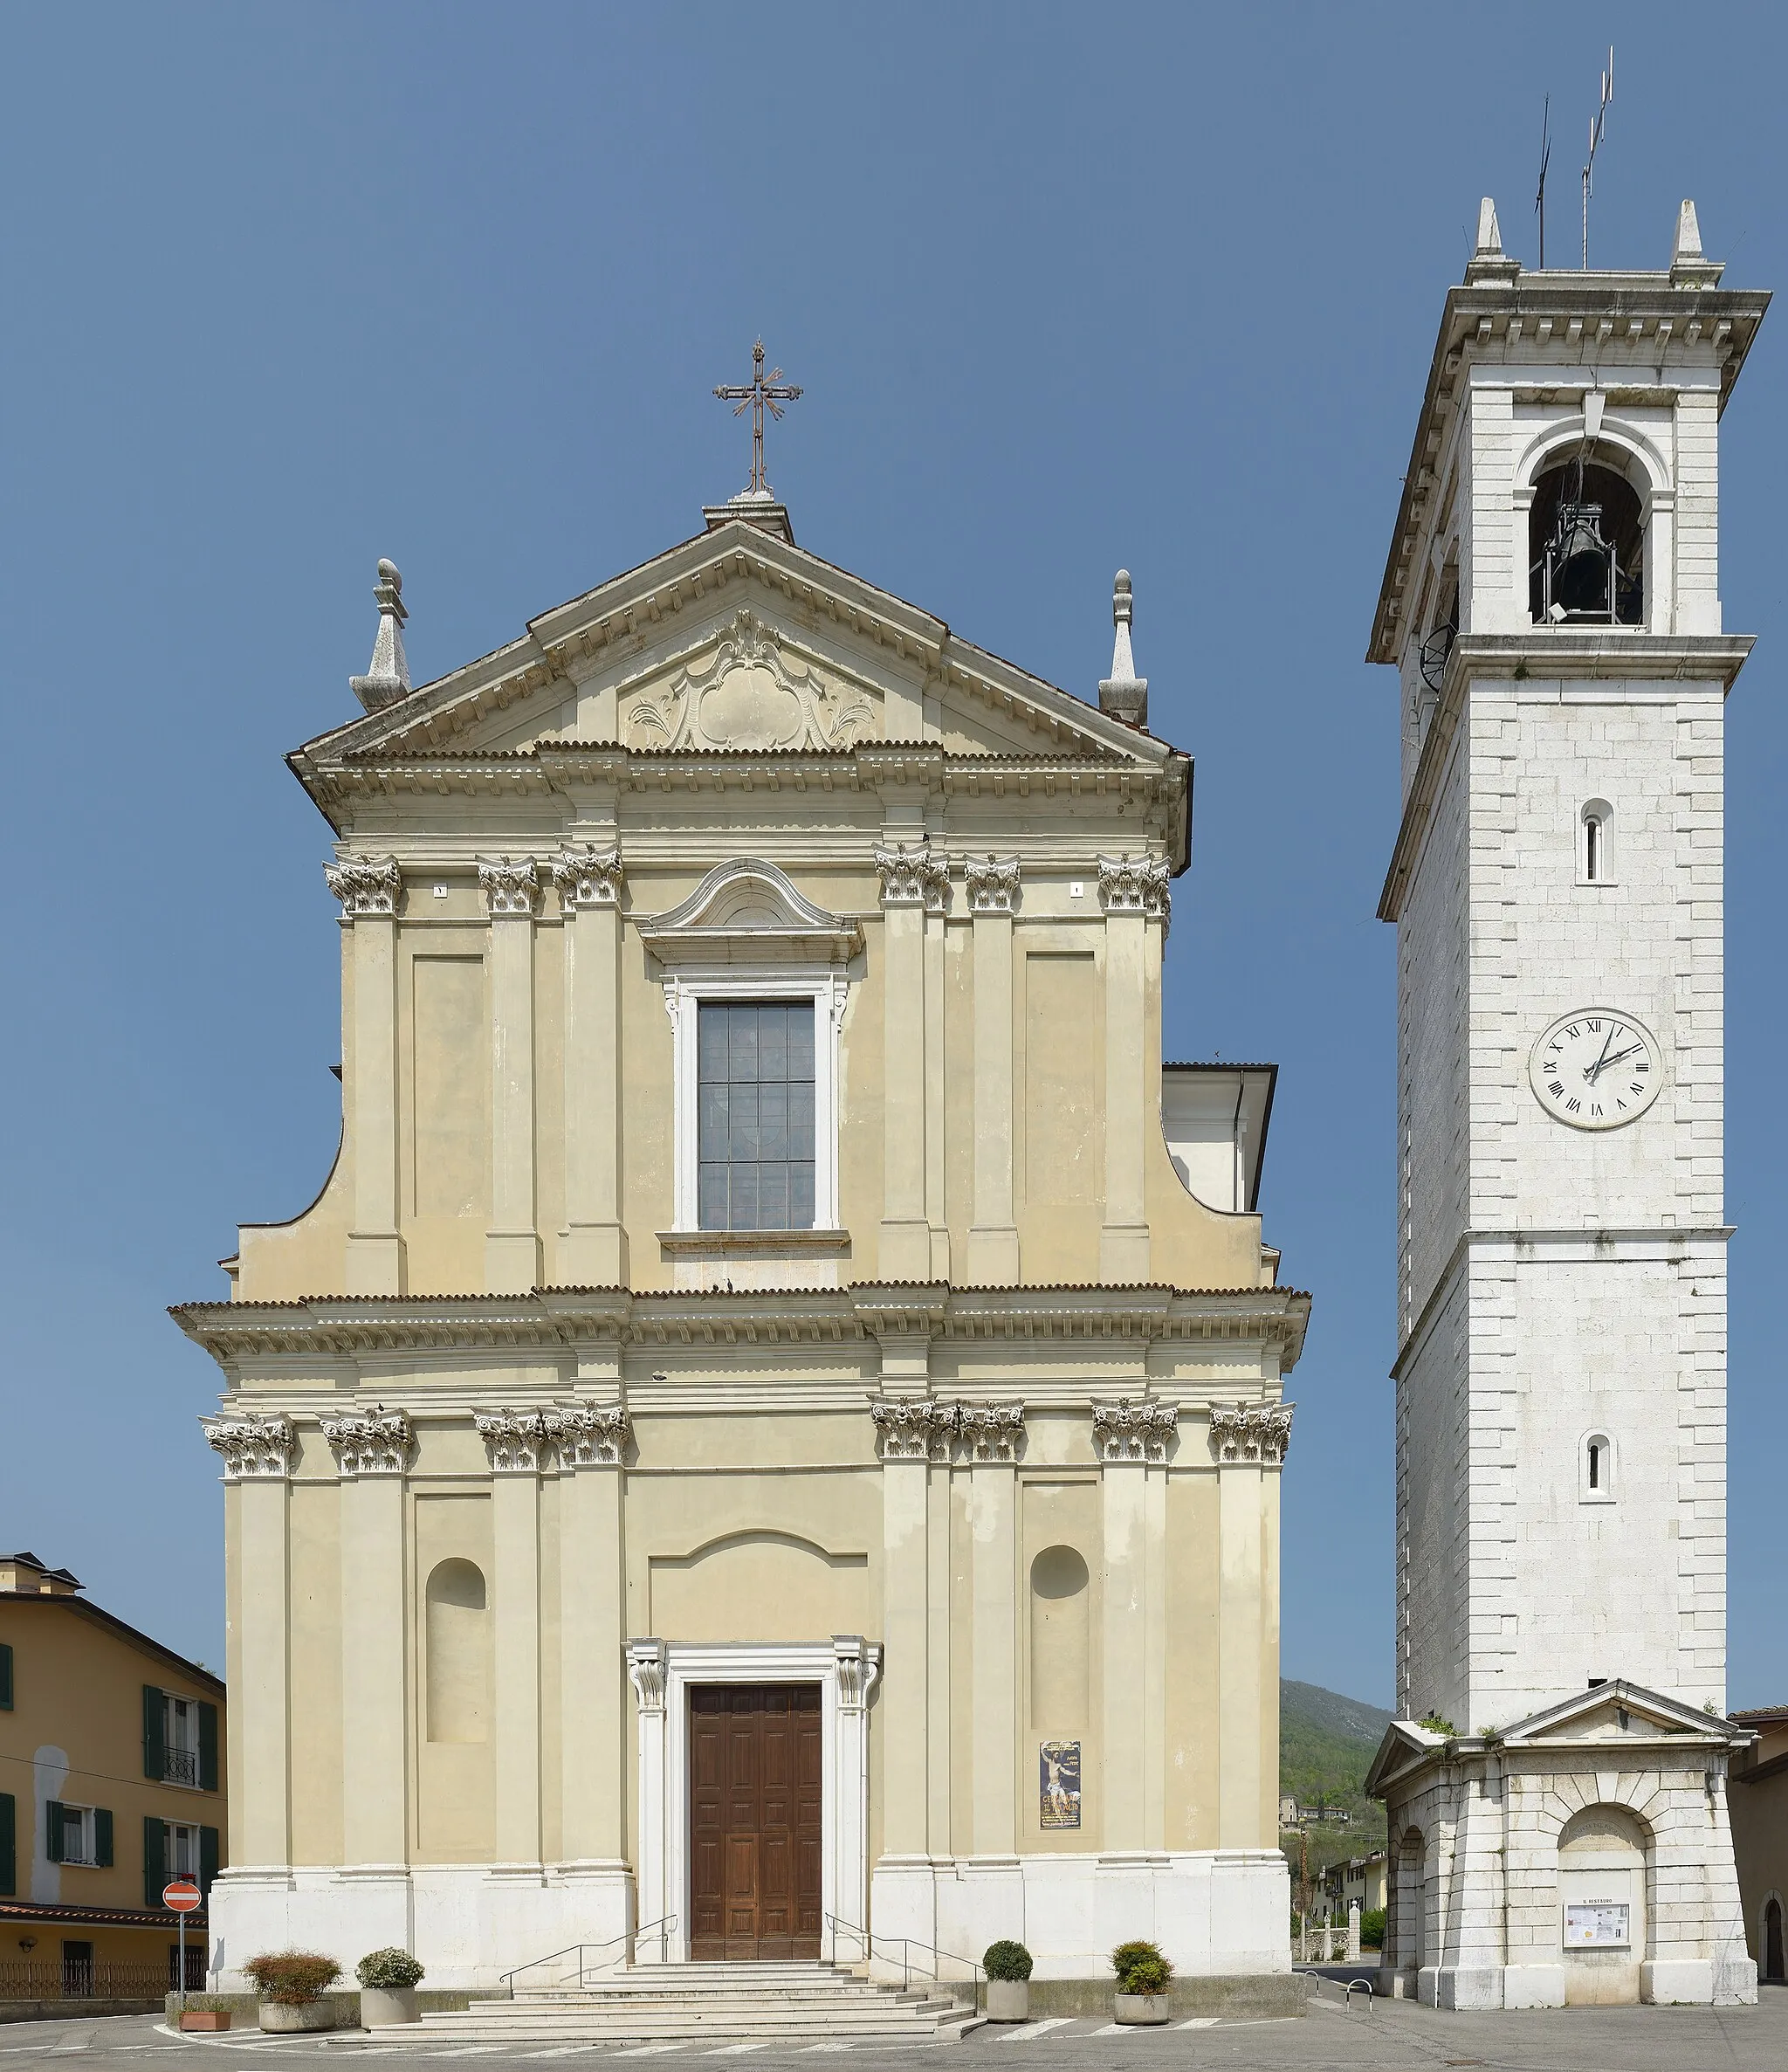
[547,843,628,1287]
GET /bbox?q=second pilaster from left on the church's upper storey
[478,856,540,1295]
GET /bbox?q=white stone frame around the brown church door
[628,1633,881,1965]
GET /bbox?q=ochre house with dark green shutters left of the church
[0,1554,228,2000]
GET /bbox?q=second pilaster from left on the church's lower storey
[323,1405,415,1876]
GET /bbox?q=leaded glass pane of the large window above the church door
[696,1001,815,1231]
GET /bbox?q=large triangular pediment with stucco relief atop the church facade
[300,520,1168,767]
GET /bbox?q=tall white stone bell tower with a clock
[1370,201,1770,2006]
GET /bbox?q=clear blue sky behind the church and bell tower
[0,0,1788,1704]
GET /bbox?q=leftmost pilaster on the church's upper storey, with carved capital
[323,856,404,1295]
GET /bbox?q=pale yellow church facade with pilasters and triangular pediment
[176,491,1307,1987]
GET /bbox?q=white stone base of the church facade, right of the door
[865,1848,1290,1981]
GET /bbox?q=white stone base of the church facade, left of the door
[210,1862,637,1993]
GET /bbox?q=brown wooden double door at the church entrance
[690,1684,822,1962]
